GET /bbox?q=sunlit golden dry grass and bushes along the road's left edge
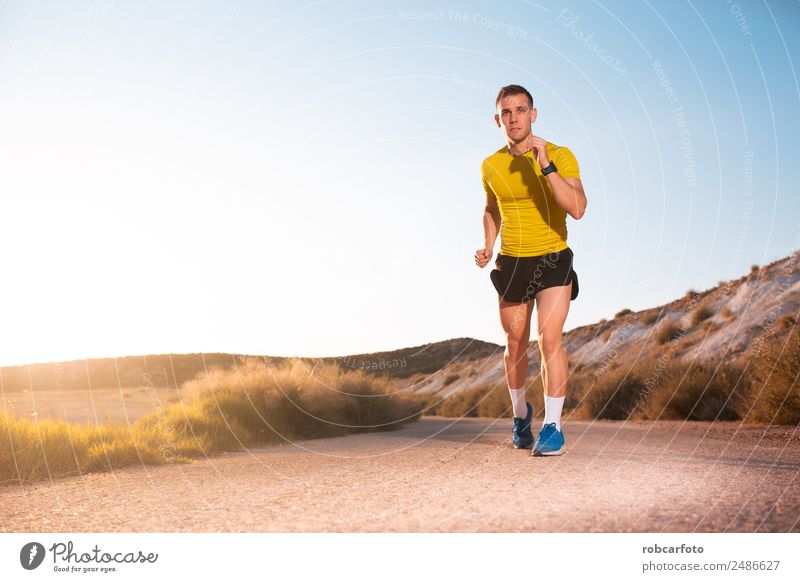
[0,358,421,483]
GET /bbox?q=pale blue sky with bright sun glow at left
[0,0,800,365]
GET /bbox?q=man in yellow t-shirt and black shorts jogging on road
[475,85,586,456]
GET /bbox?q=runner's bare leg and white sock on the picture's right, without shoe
[536,281,572,430]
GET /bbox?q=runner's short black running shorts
[489,247,578,303]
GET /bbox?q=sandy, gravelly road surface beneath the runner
[0,417,800,532]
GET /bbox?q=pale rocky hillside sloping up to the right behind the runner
[390,251,800,397]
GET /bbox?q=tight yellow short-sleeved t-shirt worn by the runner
[481,142,580,257]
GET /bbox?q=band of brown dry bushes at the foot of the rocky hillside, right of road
[412,330,800,425]
